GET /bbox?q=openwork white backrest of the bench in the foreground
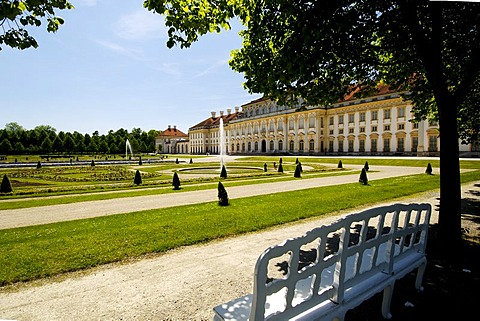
[249,203,431,321]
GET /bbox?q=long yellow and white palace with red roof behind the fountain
[188,87,479,156]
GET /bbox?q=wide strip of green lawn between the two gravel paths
[0,171,480,285]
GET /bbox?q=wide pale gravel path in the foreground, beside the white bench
[0,168,480,321]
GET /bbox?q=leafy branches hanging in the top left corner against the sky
[0,0,73,50]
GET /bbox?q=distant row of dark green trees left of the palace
[0,122,158,155]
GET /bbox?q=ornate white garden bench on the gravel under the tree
[213,203,431,321]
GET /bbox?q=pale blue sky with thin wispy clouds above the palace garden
[0,0,261,134]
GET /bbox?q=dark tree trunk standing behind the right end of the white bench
[437,100,462,263]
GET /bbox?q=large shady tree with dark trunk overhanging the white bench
[144,0,480,262]
